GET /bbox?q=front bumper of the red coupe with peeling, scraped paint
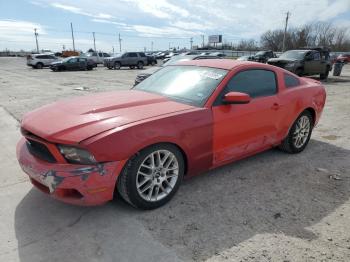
[17,138,125,206]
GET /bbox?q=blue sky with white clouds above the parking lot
[0,0,350,52]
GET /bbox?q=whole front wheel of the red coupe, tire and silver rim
[117,144,184,209]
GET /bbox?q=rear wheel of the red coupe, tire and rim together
[280,111,313,154]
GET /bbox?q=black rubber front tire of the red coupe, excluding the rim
[117,144,185,209]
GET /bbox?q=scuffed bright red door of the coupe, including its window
[212,69,283,166]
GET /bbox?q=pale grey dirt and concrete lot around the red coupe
[0,58,350,262]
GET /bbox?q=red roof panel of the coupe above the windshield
[177,59,264,70]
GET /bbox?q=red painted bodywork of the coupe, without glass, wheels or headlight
[17,59,326,205]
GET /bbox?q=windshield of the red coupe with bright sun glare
[134,66,227,106]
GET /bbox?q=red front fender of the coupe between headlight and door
[81,108,213,175]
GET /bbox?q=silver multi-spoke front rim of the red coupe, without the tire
[136,150,179,202]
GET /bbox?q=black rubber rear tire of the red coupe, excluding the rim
[279,110,314,154]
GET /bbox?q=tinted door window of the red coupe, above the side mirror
[215,69,277,105]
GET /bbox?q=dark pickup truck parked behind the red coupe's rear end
[267,48,332,79]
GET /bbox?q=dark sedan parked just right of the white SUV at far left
[50,56,97,71]
